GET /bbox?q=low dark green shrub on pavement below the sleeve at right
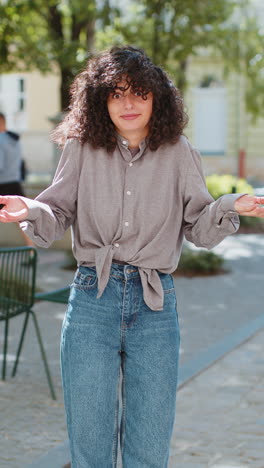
[176,248,224,276]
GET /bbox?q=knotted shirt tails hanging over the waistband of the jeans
[95,244,164,310]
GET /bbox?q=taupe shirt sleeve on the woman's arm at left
[20,140,80,247]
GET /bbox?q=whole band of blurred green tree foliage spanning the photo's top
[0,0,264,116]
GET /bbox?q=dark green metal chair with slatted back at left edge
[0,247,56,400]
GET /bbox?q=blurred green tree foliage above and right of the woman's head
[96,0,264,117]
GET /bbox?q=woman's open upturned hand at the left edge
[0,196,28,223]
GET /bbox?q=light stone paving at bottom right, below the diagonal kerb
[169,330,264,468]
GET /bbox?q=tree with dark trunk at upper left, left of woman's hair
[0,0,97,109]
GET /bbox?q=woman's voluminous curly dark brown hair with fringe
[52,46,188,153]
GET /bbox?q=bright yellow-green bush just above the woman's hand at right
[206,174,253,200]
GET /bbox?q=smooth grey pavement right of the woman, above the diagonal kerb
[175,234,264,364]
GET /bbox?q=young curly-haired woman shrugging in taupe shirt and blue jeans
[0,47,264,468]
